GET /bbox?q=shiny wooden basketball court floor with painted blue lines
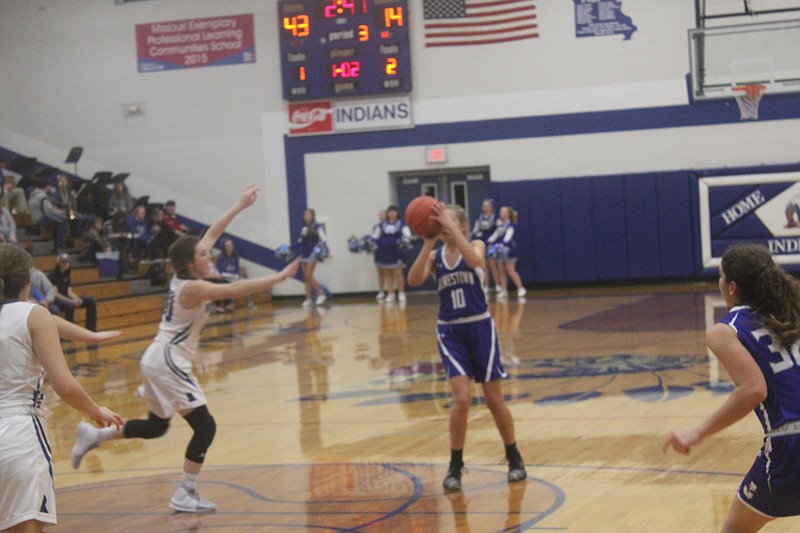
[46,283,800,533]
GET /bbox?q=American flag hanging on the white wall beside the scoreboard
[423,0,539,47]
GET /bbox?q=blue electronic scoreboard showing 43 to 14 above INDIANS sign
[278,0,411,101]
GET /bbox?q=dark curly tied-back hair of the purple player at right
[722,244,800,348]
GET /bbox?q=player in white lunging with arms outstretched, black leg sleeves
[72,186,300,513]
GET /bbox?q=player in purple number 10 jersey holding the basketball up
[408,202,527,492]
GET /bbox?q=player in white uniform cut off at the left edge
[0,244,122,533]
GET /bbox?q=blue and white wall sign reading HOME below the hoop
[698,172,800,268]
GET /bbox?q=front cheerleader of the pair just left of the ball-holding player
[372,205,411,304]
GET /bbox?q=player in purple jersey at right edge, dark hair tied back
[664,244,800,533]
